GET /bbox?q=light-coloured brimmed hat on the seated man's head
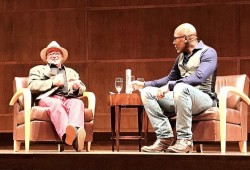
[40,41,68,62]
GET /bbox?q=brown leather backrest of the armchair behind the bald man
[215,74,249,110]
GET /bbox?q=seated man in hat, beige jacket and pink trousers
[28,41,86,151]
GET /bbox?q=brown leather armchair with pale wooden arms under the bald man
[192,75,250,153]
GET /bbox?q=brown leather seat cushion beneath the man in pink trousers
[17,106,94,125]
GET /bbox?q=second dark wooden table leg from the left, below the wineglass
[115,106,121,151]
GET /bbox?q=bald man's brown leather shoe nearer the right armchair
[167,139,193,153]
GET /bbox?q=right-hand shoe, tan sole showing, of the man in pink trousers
[73,127,86,152]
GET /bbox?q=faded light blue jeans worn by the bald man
[141,83,213,139]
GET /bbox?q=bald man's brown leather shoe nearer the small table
[141,138,174,152]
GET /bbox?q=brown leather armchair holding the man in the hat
[10,77,96,152]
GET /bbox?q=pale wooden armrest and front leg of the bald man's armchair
[219,86,250,153]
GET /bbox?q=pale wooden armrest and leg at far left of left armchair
[10,88,31,152]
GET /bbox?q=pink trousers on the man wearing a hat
[38,95,84,139]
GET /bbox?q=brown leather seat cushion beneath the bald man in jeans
[193,107,240,124]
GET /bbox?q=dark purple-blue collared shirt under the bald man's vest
[145,41,217,90]
